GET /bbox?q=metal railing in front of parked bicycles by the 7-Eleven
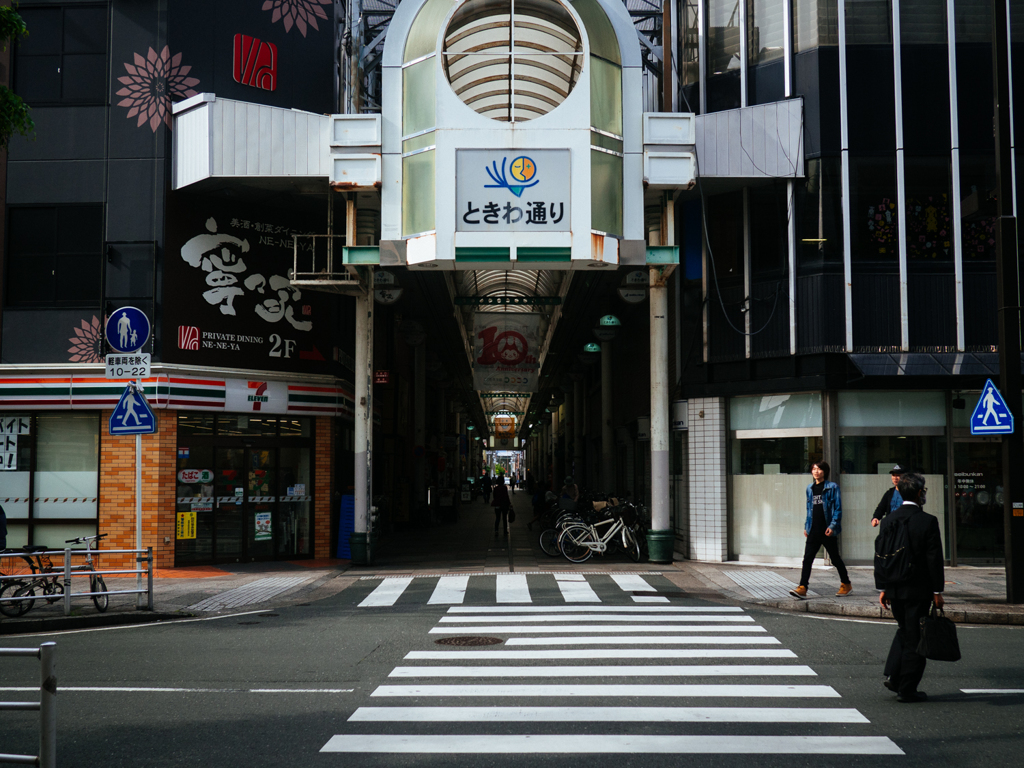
[0,547,153,616]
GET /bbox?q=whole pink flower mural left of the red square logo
[117,45,199,133]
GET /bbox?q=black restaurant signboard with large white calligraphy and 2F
[161,193,337,373]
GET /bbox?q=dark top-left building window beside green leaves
[14,5,108,106]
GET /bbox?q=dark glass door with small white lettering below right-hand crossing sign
[953,438,1005,562]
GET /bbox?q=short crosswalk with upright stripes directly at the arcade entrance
[358,572,669,608]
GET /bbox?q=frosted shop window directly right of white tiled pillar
[729,392,835,560]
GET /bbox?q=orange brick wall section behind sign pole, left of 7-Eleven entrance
[99,411,177,567]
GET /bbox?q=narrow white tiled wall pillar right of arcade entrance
[687,397,729,562]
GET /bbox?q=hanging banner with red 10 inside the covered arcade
[473,312,541,392]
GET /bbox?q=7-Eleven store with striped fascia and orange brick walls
[0,365,353,567]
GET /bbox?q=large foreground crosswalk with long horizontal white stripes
[321,602,903,765]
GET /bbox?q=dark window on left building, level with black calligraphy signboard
[7,205,103,307]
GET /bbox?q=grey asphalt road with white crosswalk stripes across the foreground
[0,574,1024,768]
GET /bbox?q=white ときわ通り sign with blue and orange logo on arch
[455,150,571,232]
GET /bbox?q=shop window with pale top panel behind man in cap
[833,391,948,562]
